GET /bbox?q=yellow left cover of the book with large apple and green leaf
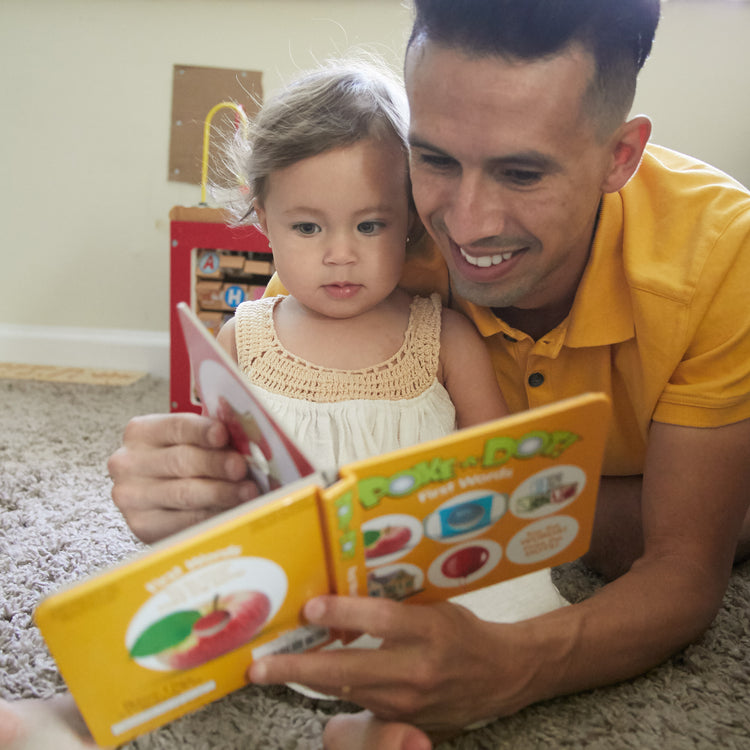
[35,483,330,745]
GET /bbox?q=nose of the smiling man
[444,173,506,246]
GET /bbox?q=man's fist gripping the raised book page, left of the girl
[108,414,258,542]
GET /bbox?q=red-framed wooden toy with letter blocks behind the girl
[169,206,273,412]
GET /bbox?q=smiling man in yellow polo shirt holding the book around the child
[110,0,750,749]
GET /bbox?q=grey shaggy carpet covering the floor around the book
[0,377,750,750]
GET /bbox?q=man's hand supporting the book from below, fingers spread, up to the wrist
[249,596,524,739]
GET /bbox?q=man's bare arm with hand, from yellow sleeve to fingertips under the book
[250,421,750,729]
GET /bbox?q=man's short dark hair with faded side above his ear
[409,0,660,138]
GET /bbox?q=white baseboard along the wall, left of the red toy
[0,323,169,378]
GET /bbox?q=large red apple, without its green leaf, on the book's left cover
[158,591,271,669]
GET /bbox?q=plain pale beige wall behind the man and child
[0,0,750,364]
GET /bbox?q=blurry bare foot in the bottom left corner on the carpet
[0,695,101,750]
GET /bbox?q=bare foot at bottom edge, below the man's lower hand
[323,711,432,750]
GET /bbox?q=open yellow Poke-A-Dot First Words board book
[35,305,609,745]
